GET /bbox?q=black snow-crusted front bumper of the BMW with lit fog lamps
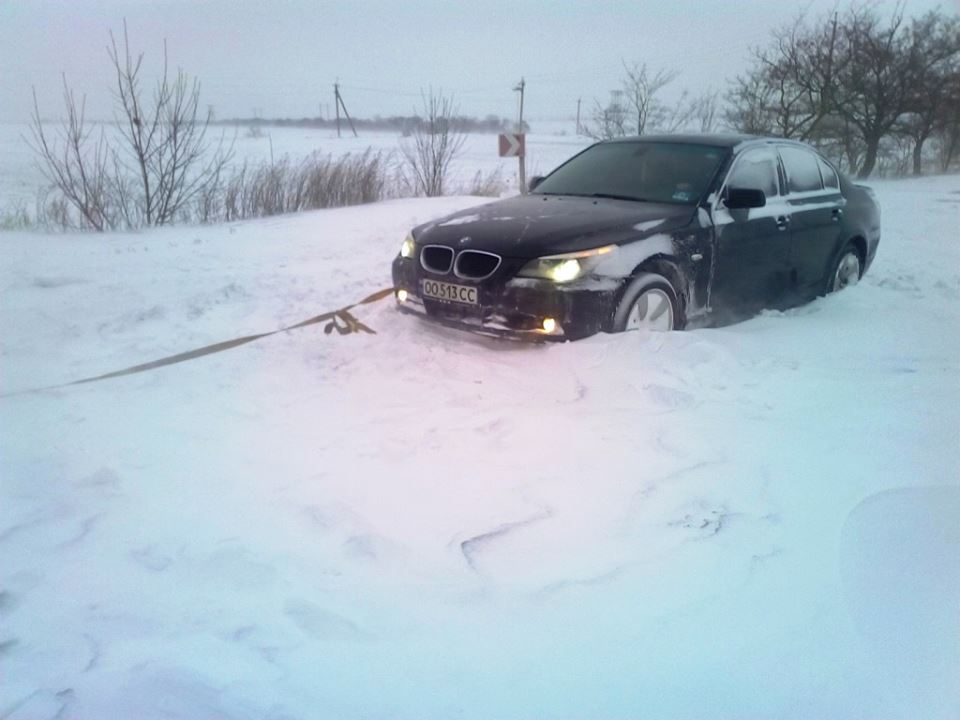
[393,258,619,342]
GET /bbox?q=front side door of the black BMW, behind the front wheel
[710,146,790,315]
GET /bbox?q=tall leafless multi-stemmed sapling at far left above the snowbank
[31,23,233,230]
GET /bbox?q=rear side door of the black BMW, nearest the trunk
[778,145,846,297]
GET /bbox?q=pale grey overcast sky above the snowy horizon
[0,0,960,122]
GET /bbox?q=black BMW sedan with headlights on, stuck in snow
[393,135,880,340]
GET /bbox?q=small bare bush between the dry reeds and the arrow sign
[400,90,466,197]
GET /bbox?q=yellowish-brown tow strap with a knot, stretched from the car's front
[0,287,393,398]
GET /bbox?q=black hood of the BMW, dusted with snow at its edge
[414,195,696,259]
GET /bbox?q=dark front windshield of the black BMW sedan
[534,141,726,205]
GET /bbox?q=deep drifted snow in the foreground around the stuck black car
[0,177,960,720]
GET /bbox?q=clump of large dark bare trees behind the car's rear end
[727,5,960,177]
